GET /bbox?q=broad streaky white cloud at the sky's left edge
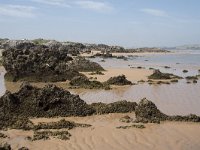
[0,5,36,18]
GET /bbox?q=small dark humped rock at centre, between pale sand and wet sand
[106,75,132,85]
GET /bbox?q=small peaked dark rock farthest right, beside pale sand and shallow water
[148,70,182,80]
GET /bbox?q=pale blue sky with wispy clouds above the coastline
[0,0,200,47]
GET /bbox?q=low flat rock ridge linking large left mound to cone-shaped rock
[91,101,137,114]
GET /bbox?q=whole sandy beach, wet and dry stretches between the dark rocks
[0,51,200,150]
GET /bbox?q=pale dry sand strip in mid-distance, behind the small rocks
[82,68,153,82]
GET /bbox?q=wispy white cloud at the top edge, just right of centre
[75,0,113,12]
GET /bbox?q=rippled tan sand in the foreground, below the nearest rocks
[1,113,200,150]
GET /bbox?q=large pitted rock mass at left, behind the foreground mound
[2,41,103,82]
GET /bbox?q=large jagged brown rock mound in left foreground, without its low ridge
[0,84,95,124]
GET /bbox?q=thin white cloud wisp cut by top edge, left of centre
[32,0,70,7]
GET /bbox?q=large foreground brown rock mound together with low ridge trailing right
[0,83,137,130]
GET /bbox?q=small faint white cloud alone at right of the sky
[140,8,168,17]
